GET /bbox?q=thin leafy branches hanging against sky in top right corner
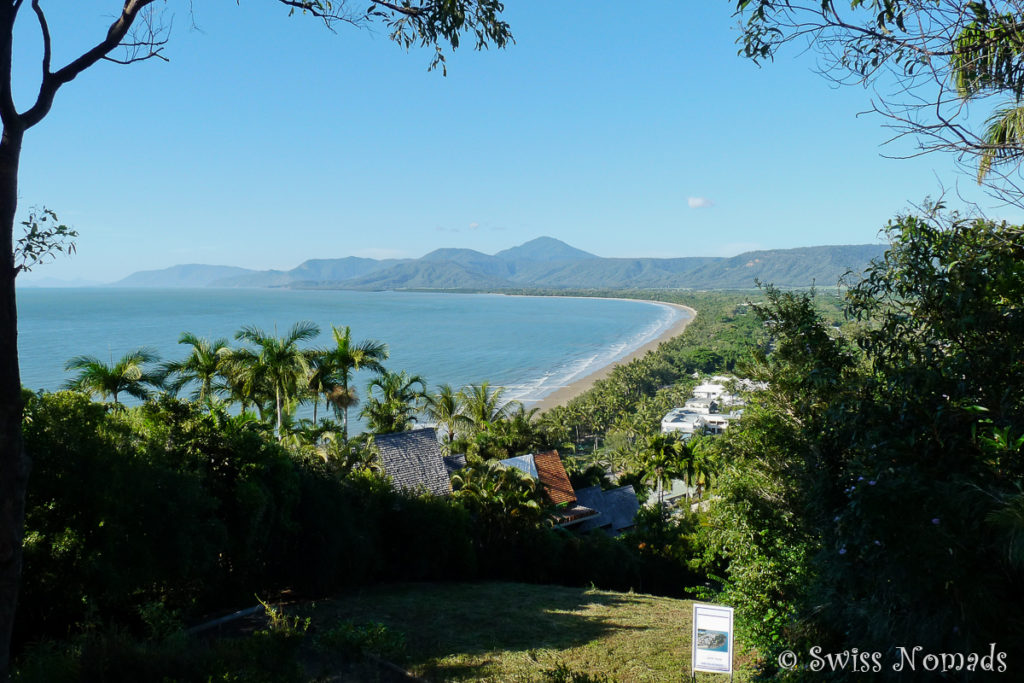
[735,0,1024,206]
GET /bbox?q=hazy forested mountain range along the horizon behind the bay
[115,238,887,290]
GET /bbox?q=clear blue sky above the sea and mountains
[8,0,1021,283]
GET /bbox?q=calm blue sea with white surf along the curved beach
[17,289,684,421]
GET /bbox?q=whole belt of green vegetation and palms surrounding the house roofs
[18,212,1024,678]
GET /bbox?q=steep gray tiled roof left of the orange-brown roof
[374,429,452,496]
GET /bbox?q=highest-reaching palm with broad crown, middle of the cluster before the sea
[234,321,319,438]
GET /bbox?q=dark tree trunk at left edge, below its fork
[0,126,30,681]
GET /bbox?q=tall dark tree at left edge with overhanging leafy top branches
[0,0,512,680]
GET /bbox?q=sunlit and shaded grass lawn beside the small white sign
[302,583,753,681]
